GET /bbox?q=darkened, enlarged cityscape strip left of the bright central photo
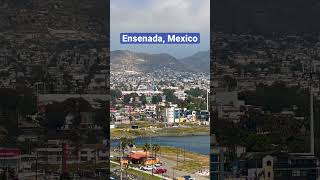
[0,0,109,179]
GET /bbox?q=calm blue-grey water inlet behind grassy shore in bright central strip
[110,135,210,155]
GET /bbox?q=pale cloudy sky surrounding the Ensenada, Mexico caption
[110,0,210,58]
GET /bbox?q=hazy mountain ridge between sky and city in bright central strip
[110,50,210,72]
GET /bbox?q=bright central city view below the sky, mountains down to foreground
[110,50,210,179]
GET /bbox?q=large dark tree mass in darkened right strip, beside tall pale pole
[213,82,309,152]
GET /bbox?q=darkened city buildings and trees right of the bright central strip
[210,32,320,179]
